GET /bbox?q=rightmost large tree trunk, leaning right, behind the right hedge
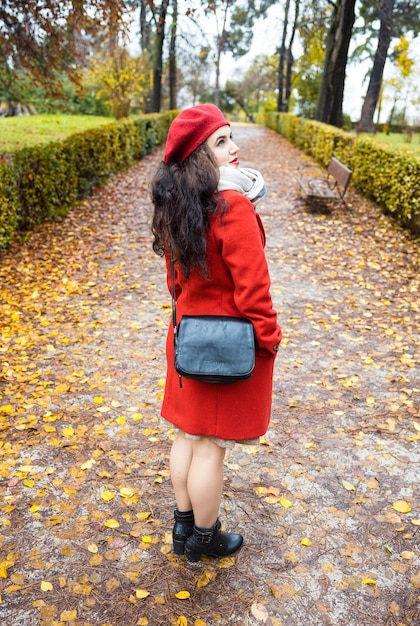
[357,0,395,133]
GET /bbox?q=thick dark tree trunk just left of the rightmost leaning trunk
[315,0,356,127]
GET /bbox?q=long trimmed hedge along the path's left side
[0,111,177,250]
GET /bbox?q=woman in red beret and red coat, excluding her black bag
[152,104,281,561]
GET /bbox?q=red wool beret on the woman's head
[163,104,230,164]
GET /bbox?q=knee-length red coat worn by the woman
[161,190,281,440]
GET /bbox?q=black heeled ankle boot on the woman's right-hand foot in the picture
[185,520,244,563]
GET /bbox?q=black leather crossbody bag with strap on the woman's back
[171,261,255,384]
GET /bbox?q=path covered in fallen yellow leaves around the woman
[0,125,420,626]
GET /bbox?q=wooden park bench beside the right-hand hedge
[298,157,353,203]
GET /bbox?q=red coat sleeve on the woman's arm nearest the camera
[214,191,281,356]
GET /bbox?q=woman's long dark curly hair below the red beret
[152,143,223,278]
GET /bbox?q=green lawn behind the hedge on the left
[0,115,115,153]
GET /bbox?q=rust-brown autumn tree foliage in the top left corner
[0,0,129,103]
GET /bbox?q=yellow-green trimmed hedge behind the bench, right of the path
[259,112,420,235]
